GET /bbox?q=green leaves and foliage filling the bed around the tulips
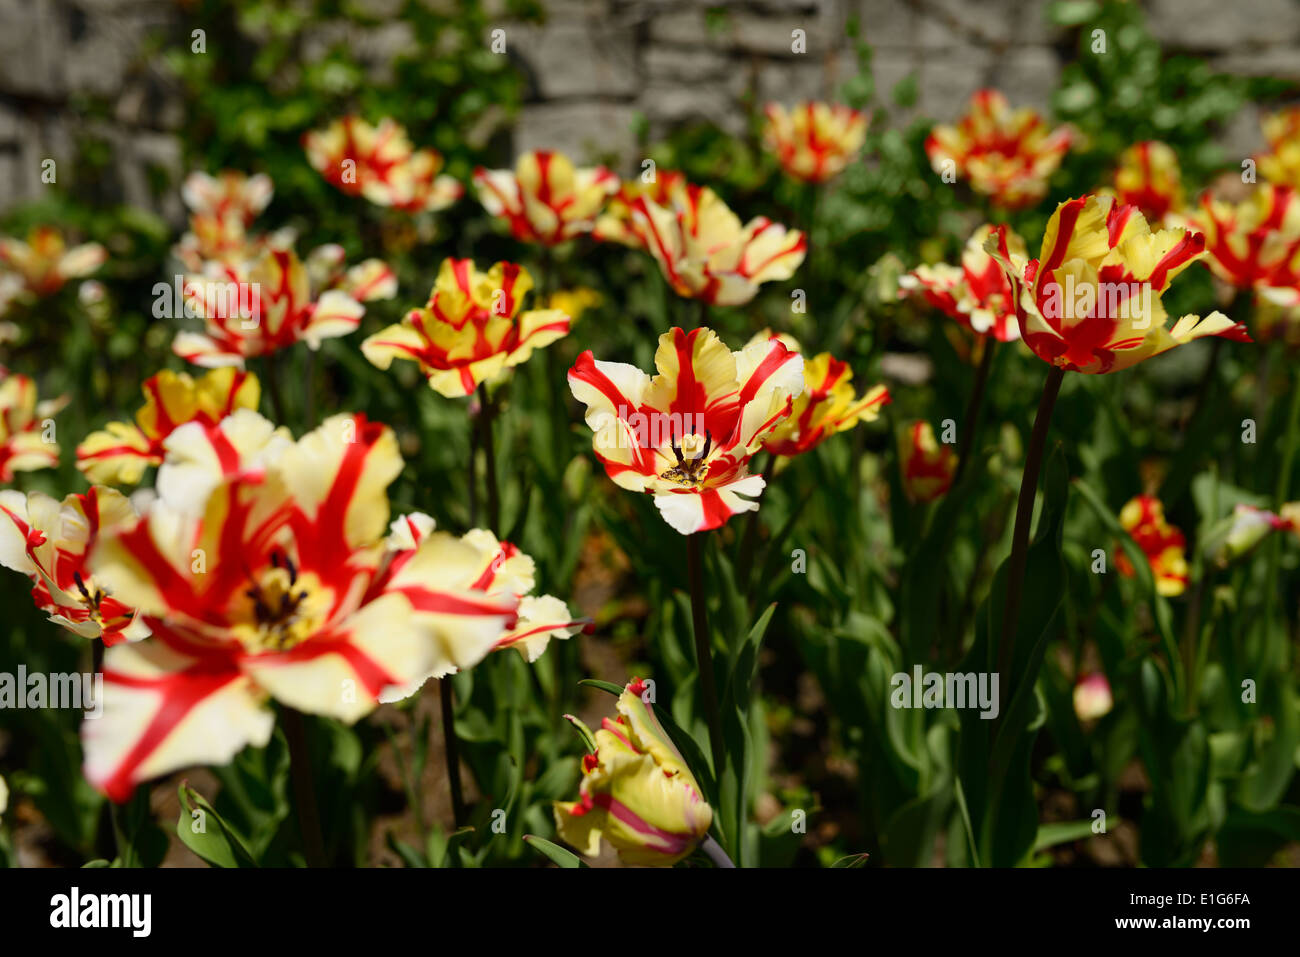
[0,0,1300,867]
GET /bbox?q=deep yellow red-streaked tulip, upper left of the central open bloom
[361,259,569,398]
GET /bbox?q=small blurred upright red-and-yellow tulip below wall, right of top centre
[763,103,870,183]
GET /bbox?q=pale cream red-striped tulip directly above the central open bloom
[632,185,807,306]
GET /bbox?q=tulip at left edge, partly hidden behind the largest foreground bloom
[0,485,150,645]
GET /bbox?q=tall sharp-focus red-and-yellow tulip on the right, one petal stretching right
[987,196,1249,374]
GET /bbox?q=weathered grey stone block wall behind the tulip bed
[0,0,1300,215]
